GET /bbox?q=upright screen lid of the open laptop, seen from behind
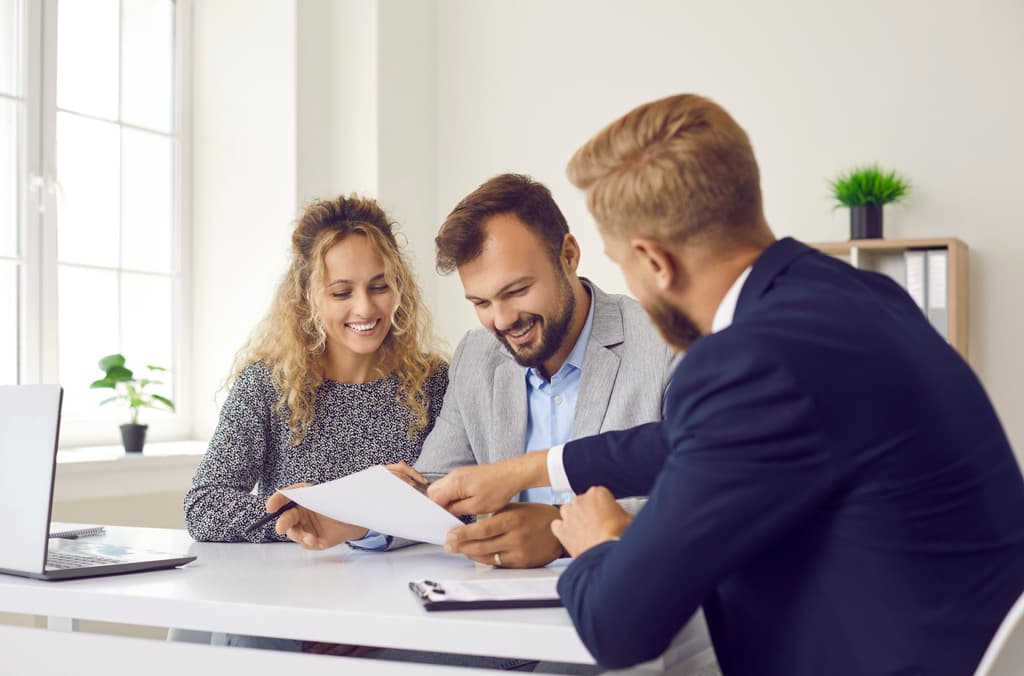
[0,385,63,574]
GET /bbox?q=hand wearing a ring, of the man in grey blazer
[444,502,562,568]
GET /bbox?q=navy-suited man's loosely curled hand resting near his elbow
[551,485,633,557]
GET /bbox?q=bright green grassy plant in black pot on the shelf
[828,165,910,240]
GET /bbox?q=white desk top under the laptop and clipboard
[0,526,593,664]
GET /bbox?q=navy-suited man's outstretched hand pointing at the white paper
[427,451,548,514]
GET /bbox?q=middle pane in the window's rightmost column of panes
[121,128,174,272]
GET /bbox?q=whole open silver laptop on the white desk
[0,385,196,580]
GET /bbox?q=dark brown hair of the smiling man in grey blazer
[434,174,569,274]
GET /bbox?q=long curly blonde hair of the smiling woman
[228,195,443,445]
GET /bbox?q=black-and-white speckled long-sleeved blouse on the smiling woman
[184,363,447,542]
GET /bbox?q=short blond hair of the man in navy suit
[567,94,764,242]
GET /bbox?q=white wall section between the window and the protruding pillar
[191,0,297,438]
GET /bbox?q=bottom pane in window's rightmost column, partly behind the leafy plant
[121,272,174,413]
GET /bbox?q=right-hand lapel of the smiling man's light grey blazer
[572,280,624,438]
